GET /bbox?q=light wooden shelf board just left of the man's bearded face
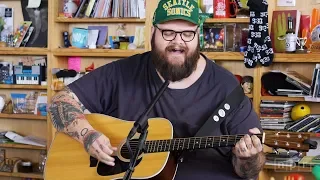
[53,48,145,57]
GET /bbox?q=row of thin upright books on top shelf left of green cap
[73,0,145,18]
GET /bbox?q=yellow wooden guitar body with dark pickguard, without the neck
[44,114,177,180]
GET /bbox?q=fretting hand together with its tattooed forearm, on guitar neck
[232,128,265,179]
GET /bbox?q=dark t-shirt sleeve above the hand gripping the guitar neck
[227,96,262,135]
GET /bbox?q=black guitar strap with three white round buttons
[177,85,245,163]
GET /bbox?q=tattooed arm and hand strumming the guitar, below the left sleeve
[48,87,116,166]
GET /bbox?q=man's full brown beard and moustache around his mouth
[151,33,200,82]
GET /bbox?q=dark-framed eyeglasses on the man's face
[155,26,199,42]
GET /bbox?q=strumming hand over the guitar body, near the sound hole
[83,130,117,166]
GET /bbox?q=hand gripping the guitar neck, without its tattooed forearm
[233,128,262,159]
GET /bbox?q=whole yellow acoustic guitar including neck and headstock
[44,114,317,180]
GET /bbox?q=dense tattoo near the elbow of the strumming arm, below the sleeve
[48,87,85,138]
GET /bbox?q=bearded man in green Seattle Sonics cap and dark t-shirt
[49,0,265,180]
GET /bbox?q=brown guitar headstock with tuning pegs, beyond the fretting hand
[264,131,317,152]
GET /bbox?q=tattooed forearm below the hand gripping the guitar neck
[232,152,265,179]
